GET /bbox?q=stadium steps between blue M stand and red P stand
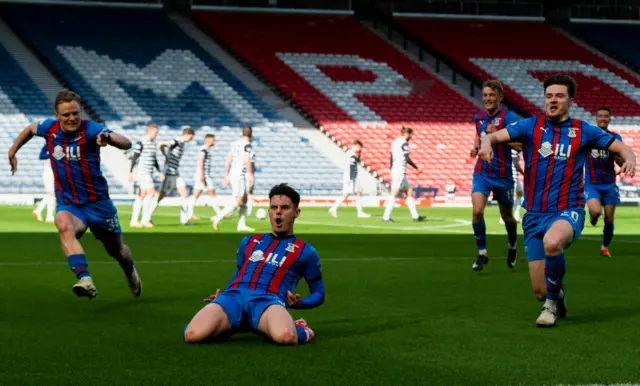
[167,12,382,194]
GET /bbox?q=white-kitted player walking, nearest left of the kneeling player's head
[213,126,255,232]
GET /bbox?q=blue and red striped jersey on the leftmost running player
[36,119,111,205]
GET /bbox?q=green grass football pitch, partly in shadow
[0,206,640,386]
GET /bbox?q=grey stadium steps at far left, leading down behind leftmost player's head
[0,18,64,103]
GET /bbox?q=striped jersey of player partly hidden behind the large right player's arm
[473,109,518,179]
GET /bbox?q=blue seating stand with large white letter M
[0,4,342,194]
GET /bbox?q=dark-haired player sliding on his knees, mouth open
[184,184,324,345]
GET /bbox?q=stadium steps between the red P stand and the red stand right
[361,21,484,109]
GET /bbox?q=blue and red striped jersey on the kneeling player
[227,233,322,304]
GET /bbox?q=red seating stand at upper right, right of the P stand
[396,17,640,184]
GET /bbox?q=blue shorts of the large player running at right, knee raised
[522,209,584,261]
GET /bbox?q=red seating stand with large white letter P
[193,11,477,194]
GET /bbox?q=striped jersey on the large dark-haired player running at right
[507,116,614,212]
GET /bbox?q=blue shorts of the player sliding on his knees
[211,288,286,331]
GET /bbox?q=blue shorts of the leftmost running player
[56,199,122,239]
